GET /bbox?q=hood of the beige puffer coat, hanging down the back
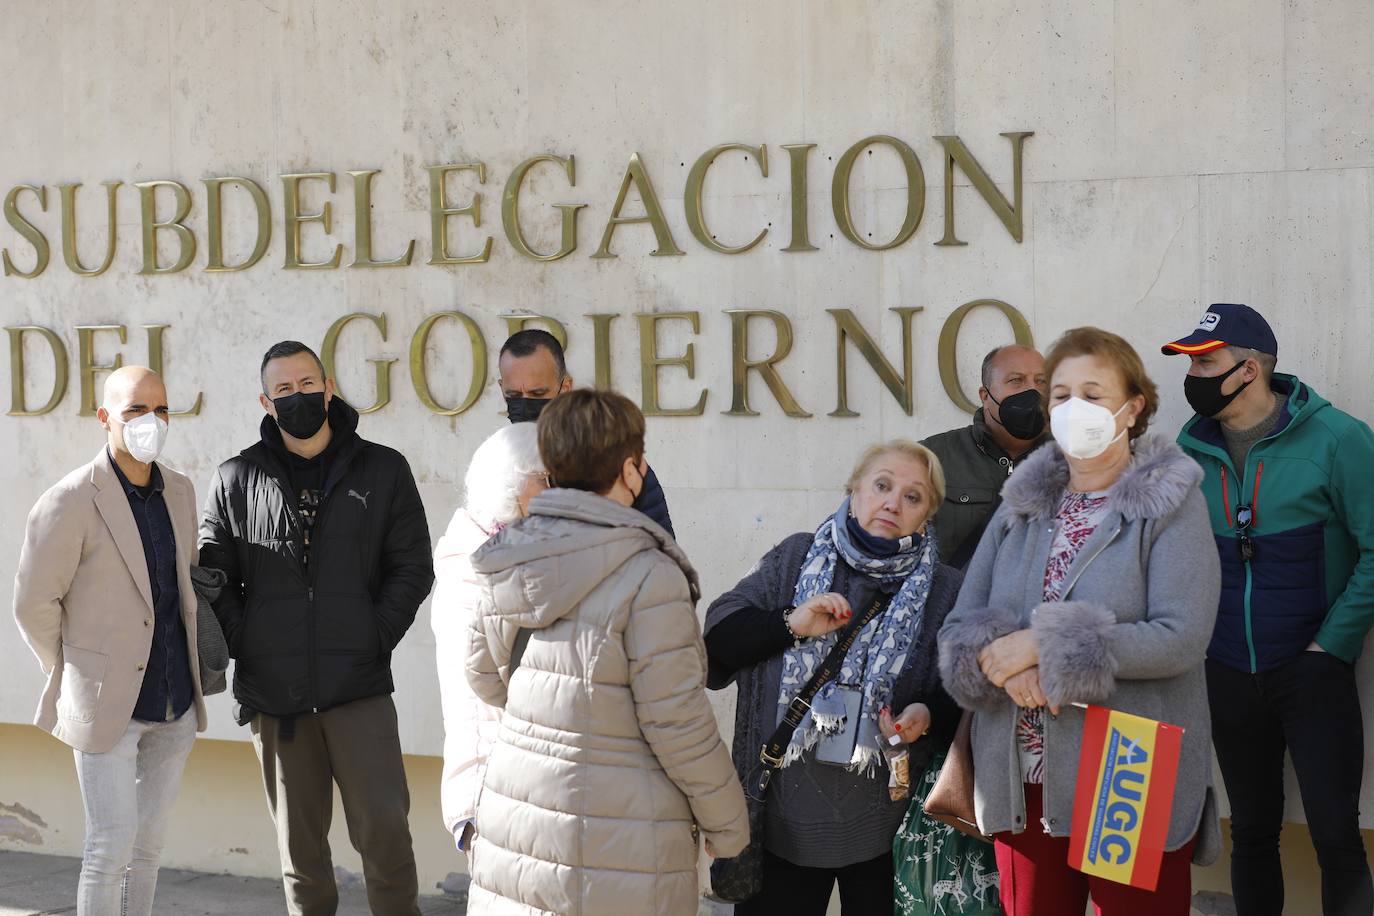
[473,488,701,629]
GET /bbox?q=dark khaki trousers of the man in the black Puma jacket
[251,696,420,916]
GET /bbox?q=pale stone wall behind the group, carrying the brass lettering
[0,0,1374,900]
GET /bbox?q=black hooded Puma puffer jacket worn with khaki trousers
[201,397,434,721]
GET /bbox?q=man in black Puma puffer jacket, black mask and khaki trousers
[201,341,434,916]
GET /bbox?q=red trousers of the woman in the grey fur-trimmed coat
[993,783,1197,916]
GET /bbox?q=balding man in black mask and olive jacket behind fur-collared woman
[923,343,1050,570]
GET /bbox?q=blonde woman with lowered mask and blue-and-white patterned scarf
[706,439,959,916]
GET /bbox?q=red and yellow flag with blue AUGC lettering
[1069,706,1183,890]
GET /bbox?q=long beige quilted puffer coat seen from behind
[467,489,749,916]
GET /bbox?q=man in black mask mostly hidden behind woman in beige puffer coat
[497,328,677,537]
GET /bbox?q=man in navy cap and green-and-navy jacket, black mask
[1162,304,1374,916]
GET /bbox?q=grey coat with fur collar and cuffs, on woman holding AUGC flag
[940,437,1221,865]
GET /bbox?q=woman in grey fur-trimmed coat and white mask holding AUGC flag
[938,328,1220,916]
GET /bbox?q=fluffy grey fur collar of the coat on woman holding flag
[1002,435,1202,522]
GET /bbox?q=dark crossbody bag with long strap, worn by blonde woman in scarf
[710,596,889,904]
